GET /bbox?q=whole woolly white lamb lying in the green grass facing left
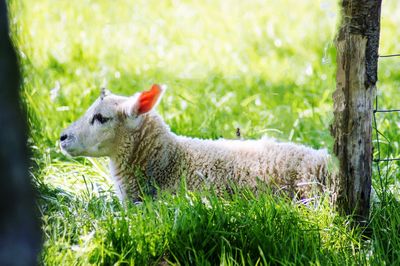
[60,85,329,201]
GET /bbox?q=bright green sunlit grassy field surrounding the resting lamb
[8,0,400,265]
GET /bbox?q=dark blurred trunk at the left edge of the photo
[0,0,40,265]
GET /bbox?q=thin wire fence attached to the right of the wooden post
[373,54,400,200]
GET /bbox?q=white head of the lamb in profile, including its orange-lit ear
[60,85,165,157]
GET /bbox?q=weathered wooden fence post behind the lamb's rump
[332,0,381,222]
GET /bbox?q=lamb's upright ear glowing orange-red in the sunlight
[122,84,166,116]
